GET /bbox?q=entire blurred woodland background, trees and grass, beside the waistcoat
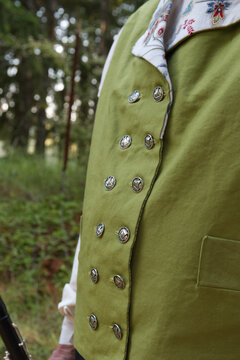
[0,0,144,360]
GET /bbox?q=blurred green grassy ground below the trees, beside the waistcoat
[0,156,85,360]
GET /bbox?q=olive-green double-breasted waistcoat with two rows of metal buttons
[74,0,240,360]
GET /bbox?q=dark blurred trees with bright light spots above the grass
[0,0,144,154]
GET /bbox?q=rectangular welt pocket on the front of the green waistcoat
[197,235,240,291]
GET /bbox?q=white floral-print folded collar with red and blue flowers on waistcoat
[132,0,240,138]
